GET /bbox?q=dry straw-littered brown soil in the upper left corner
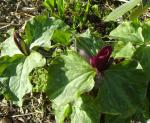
[0,0,42,31]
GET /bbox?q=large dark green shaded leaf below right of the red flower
[97,61,148,117]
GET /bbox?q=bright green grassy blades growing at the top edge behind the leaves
[43,0,93,29]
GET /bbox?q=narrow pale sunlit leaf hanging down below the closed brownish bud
[9,52,46,106]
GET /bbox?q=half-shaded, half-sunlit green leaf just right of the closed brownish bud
[25,16,68,48]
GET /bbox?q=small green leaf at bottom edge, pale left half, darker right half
[71,96,100,123]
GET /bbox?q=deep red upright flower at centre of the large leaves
[90,46,112,72]
